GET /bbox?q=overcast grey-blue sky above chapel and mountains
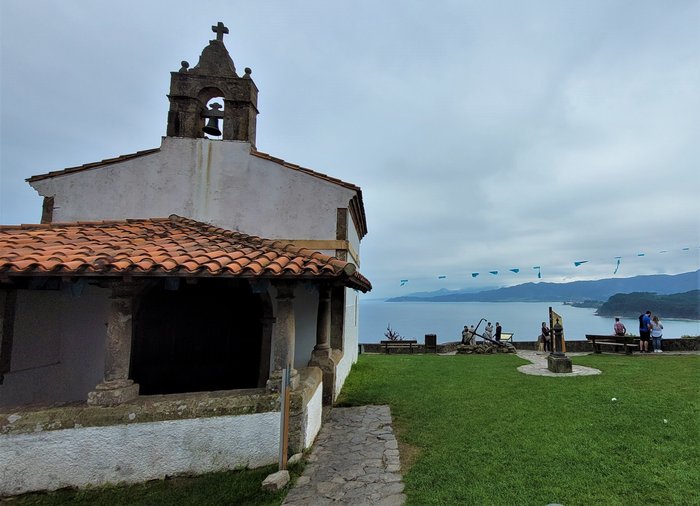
[0,0,700,297]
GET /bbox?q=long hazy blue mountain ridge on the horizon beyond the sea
[387,270,700,302]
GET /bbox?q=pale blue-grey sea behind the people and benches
[359,299,700,343]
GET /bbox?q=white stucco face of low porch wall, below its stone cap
[0,411,280,496]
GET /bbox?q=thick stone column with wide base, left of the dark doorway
[88,283,139,406]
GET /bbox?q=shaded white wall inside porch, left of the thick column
[0,285,109,406]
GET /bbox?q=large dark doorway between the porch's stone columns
[131,279,263,395]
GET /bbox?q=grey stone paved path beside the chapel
[282,406,406,506]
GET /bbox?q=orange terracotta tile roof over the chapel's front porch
[0,215,372,292]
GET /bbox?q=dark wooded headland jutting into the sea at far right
[596,290,700,320]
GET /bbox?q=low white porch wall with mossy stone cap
[0,367,322,497]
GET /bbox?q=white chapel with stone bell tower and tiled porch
[0,23,371,496]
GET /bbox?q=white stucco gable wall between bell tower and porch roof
[32,137,354,239]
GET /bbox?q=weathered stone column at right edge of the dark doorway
[267,281,299,391]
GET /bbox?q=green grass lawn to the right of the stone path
[339,355,700,506]
